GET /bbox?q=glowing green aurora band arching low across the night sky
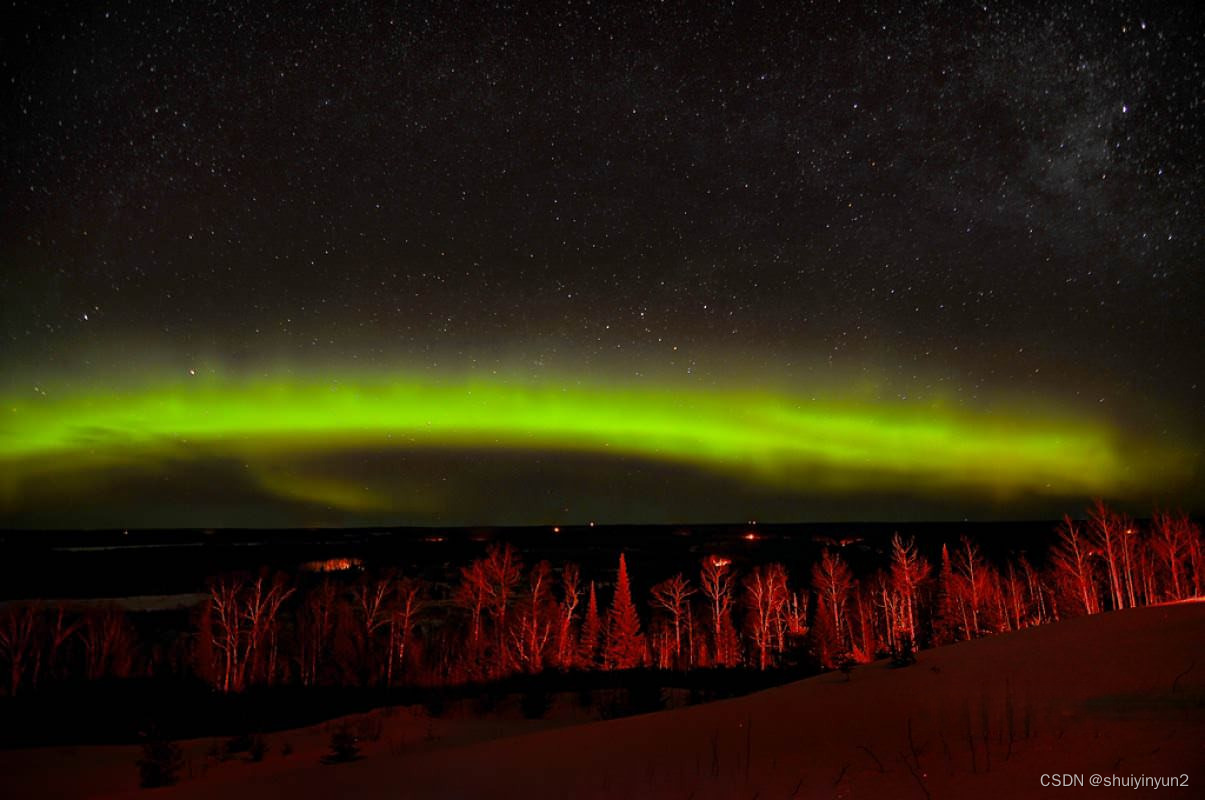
[0,375,1191,525]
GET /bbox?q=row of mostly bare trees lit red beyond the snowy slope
[0,502,1205,695]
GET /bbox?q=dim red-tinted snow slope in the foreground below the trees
[11,602,1205,800]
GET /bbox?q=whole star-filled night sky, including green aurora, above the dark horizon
[0,1,1205,528]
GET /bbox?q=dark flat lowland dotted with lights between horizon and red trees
[0,520,1057,600]
